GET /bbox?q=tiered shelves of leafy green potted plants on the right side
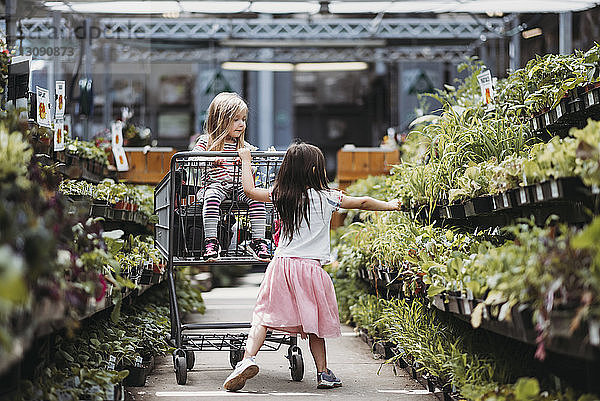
[329,46,600,400]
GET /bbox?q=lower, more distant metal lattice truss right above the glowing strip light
[108,46,474,63]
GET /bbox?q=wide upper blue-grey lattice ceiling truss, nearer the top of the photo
[20,17,505,40]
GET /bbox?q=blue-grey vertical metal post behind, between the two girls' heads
[257,71,275,150]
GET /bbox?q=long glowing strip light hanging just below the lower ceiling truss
[221,61,369,72]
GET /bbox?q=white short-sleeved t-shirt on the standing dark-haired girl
[274,189,342,264]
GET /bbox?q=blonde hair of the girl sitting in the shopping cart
[204,92,248,151]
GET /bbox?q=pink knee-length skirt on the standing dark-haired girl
[252,257,341,338]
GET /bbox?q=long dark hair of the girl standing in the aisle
[272,143,329,239]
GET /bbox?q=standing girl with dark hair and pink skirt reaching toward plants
[223,143,400,391]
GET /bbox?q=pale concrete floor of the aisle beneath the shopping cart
[127,273,437,401]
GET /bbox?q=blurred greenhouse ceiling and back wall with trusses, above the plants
[0,0,600,173]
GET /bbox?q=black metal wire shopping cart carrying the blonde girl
[154,152,304,384]
